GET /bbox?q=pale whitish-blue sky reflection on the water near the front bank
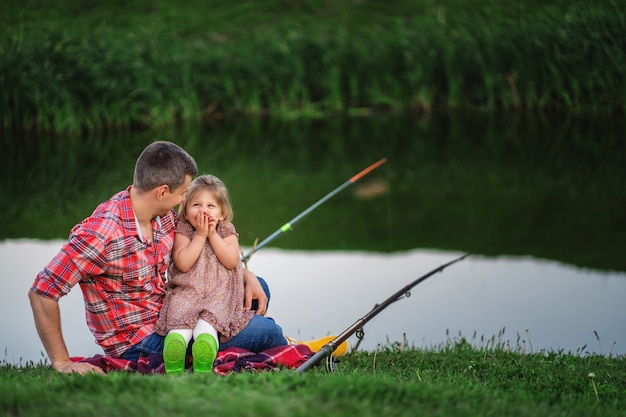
[0,240,626,363]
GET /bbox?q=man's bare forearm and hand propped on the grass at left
[28,290,104,374]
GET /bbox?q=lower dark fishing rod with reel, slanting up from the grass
[296,253,470,374]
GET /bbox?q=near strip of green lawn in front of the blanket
[0,339,626,417]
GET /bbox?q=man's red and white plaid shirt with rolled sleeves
[32,187,176,357]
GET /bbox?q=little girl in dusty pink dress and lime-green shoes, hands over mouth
[156,175,254,374]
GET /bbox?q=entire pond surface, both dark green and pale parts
[0,114,626,360]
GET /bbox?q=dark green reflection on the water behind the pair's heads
[0,112,626,271]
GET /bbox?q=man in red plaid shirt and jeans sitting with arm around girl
[29,141,287,374]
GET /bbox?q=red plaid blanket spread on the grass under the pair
[72,345,313,375]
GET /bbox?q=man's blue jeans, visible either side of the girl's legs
[120,277,287,362]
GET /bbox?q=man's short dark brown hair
[133,141,198,192]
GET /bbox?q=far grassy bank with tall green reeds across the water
[0,0,626,133]
